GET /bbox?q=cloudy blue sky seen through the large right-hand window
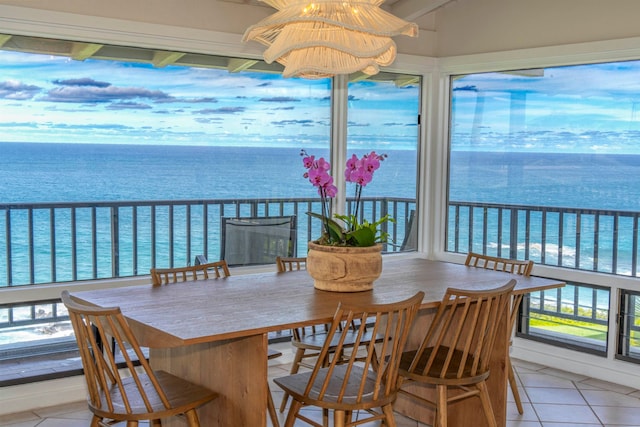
[452,61,640,154]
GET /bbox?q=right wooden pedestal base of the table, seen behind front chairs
[393,310,509,427]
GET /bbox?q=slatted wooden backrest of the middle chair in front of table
[305,292,424,404]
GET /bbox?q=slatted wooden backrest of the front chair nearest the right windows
[408,279,516,380]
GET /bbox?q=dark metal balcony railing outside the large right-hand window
[447,202,640,277]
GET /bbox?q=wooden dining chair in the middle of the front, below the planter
[274,292,424,427]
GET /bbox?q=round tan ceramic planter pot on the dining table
[307,242,382,292]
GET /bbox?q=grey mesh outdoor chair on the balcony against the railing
[220,215,297,266]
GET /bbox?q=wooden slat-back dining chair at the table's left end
[61,290,218,427]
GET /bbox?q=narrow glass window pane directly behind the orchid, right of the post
[347,73,420,252]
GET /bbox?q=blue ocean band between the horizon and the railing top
[0,143,640,212]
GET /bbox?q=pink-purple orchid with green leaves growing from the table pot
[300,150,394,247]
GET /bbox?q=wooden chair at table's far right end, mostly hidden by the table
[465,252,533,414]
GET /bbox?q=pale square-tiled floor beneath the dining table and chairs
[0,360,640,427]
